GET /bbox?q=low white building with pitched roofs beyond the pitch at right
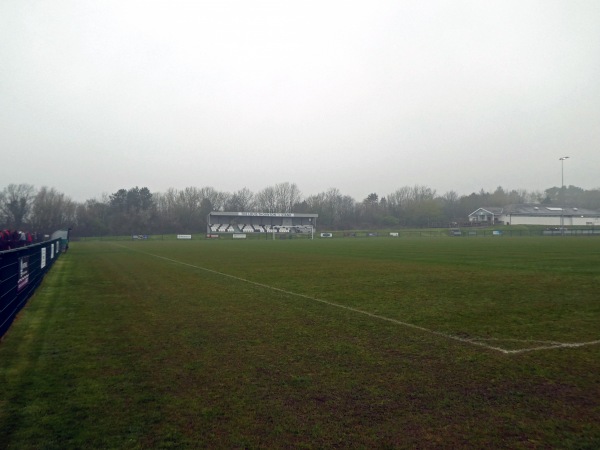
[469,204,600,227]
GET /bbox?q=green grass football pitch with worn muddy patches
[0,237,600,448]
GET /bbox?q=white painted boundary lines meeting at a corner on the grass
[120,244,600,355]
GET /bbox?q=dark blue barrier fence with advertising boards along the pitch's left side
[0,239,61,337]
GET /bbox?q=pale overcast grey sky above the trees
[0,0,600,201]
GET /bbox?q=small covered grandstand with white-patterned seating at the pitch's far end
[206,211,319,234]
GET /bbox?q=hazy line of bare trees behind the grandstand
[0,182,600,236]
